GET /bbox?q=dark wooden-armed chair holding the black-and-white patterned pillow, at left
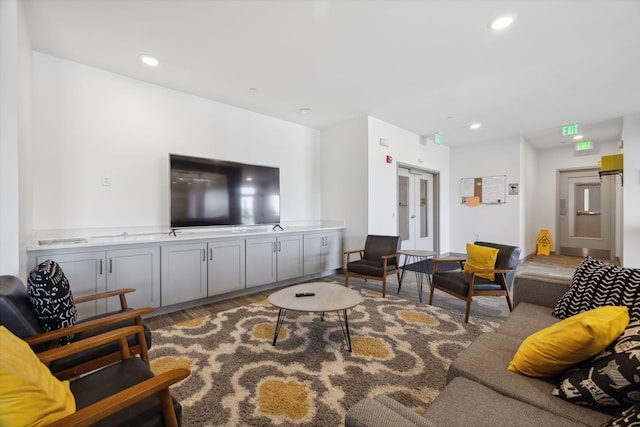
[0,275,153,379]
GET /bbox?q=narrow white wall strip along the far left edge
[0,0,20,275]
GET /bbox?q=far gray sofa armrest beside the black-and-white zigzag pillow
[513,274,571,308]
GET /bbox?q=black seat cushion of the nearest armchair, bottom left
[71,357,182,427]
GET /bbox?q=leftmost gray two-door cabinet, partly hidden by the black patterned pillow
[29,246,160,318]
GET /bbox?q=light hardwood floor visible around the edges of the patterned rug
[146,255,583,330]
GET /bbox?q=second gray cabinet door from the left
[107,246,160,311]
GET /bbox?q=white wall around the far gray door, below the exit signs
[531,141,620,251]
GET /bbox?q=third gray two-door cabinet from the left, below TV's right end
[246,234,303,287]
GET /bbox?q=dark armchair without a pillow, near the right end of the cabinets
[345,234,400,298]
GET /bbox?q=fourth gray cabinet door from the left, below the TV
[208,239,245,296]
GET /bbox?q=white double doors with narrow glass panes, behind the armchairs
[398,166,439,253]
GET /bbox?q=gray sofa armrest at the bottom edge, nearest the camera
[344,395,436,427]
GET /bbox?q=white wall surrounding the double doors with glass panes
[368,117,449,252]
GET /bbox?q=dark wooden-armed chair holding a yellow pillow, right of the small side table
[429,242,520,323]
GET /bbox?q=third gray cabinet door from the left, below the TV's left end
[161,243,207,306]
